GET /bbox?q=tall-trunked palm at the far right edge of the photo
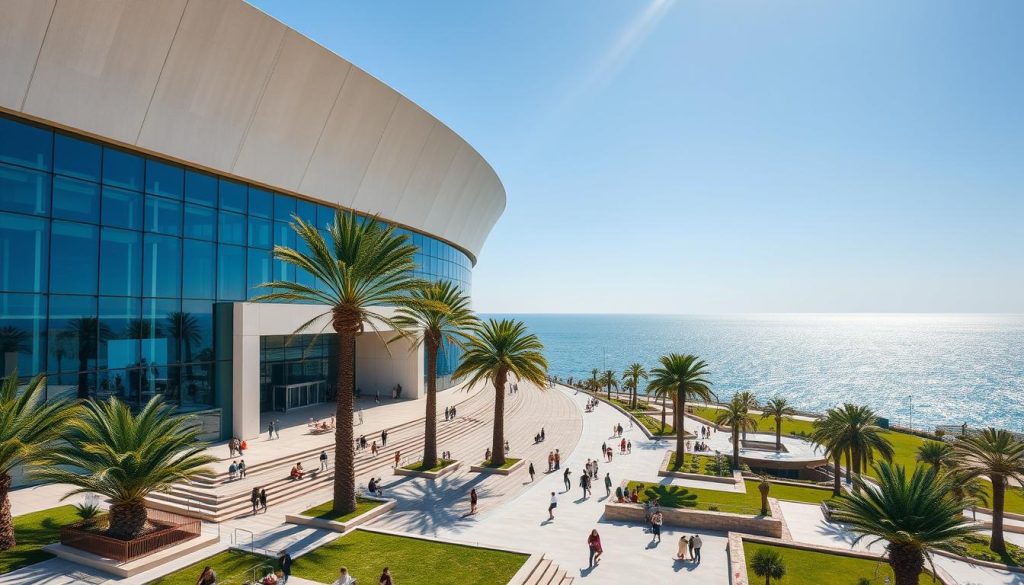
[953,427,1024,554]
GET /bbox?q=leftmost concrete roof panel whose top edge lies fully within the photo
[232,31,352,191]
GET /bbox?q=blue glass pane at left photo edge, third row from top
[0,213,49,292]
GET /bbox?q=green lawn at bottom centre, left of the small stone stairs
[292,530,527,585]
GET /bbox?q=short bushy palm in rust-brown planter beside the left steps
[34,396,217,540]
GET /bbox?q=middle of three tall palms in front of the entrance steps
[395,281,478,469]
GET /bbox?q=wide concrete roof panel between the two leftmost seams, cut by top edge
[25,0,185,143]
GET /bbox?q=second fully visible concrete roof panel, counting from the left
[299,68,399,207]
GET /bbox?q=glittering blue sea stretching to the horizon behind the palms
[484,315,1024,431]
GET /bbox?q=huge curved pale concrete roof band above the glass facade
[0,0,505,257]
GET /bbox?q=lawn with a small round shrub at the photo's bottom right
[743,542,897,585]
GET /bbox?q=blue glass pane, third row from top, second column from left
[50,220,99,294]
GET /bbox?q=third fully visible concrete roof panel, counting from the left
[352,97,434,217]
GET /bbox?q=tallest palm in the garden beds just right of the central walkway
[650,353,715,469]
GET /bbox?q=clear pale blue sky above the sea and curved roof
[253,0,1024,314]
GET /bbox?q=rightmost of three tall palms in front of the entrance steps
[452,319,548,467]
